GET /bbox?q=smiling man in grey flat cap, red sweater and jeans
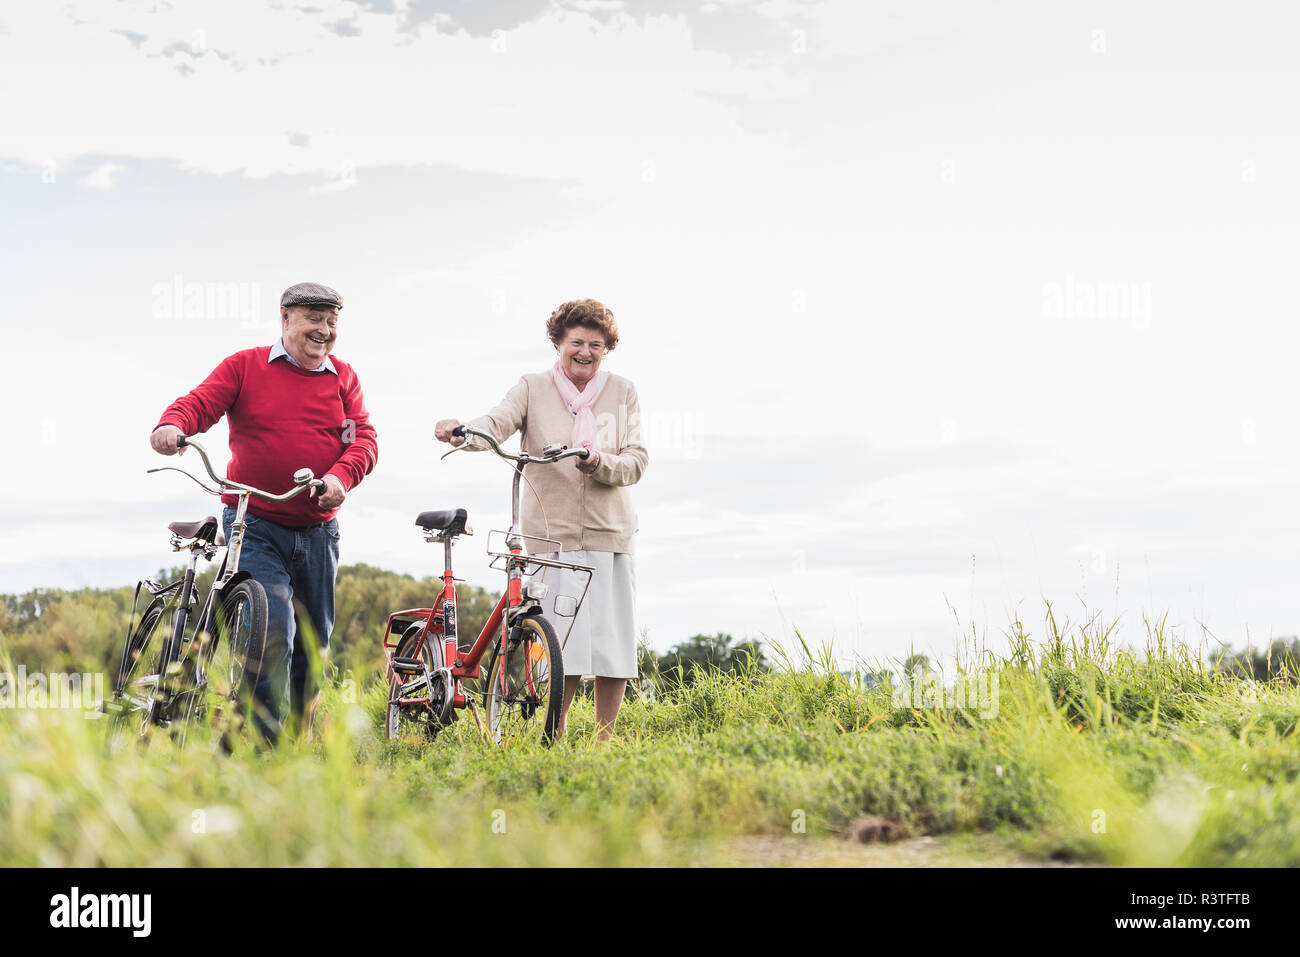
[150,282,378,741]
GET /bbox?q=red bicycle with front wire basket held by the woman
[384,425,592,744]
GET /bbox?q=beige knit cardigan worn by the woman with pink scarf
[465,369,650,554]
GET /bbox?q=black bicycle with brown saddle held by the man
[105,436,324,748]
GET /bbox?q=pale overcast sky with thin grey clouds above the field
[0,0,1300,659]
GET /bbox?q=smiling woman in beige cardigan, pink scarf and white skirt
[434,299,650,740]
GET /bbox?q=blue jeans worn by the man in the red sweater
[221,506,338,741]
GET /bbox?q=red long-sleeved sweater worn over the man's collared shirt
[155,346,378,528]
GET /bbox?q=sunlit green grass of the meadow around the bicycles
[0,615,1300,866]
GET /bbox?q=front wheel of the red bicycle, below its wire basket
[484,615,564,744]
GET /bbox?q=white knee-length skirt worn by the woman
[542,549,637,677]
